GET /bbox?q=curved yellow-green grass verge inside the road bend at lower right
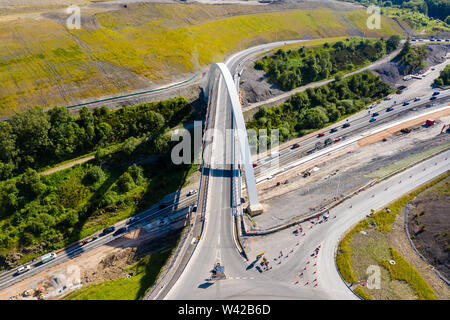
[336,173,450,300]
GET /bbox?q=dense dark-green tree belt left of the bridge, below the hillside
[0,97,192,180]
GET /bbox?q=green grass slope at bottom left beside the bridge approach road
[64,247,173,300]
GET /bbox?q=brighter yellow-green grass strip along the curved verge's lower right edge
[381,247,436,300]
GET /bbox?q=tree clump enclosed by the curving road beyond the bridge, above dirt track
[255,35,400,90]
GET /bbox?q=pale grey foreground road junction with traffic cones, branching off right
[166,141,450,300]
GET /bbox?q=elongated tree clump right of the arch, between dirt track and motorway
[247,71,393,145]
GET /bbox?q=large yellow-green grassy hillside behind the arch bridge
[0,4,401,117]
